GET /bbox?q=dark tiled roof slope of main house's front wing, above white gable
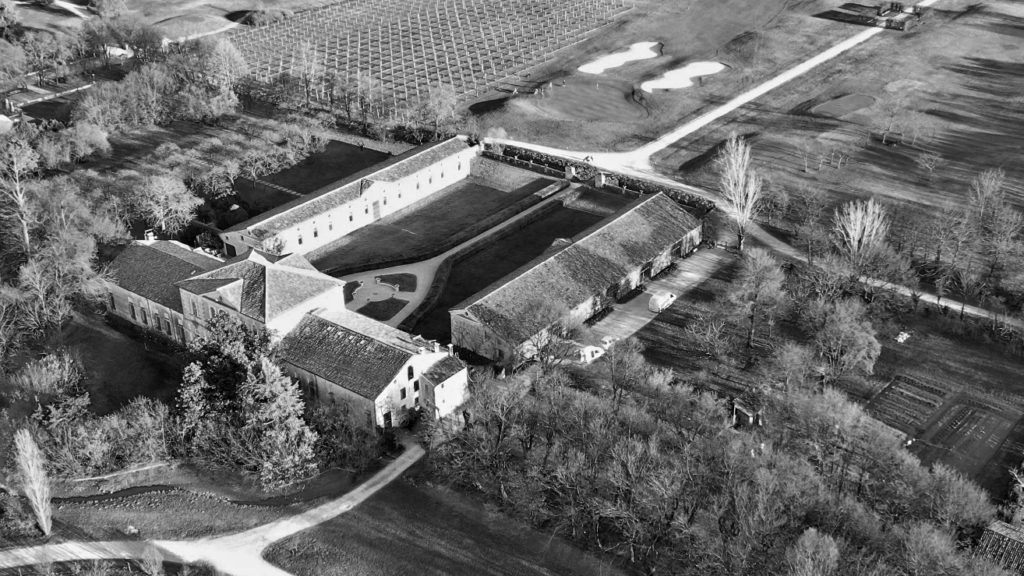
[280,314,416,400]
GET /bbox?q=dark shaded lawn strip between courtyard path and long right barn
[412,190,630,341]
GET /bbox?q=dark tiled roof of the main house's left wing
[110,240,223,312]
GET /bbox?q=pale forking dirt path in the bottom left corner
[0,439,424,576]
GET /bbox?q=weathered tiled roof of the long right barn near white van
[453,193,700,344]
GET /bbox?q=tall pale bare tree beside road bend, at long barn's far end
[715,132,762,252]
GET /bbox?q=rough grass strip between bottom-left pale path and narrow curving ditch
[53,490,290,540]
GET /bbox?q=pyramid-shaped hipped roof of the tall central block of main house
[177,250,342,322]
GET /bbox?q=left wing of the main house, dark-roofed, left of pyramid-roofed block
[106,240,224,344]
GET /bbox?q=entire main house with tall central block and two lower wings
[108,241,467,427]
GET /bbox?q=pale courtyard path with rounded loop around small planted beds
[341,184,575,326]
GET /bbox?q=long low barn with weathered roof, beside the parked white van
[450,193,701,361]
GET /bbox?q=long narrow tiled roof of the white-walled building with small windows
[226,136,468,238]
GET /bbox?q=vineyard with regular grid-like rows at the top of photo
[231,0,628,108]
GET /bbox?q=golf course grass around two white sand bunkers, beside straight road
[479,0,862,150]
